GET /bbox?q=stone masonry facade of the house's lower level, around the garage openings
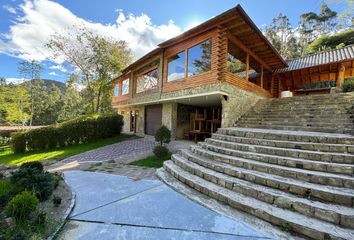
[118,82,262,138]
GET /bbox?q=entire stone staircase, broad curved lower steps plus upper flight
[157,94,354,240]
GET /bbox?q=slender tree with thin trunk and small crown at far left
[18,60,43,126]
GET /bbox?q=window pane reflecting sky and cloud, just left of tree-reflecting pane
[167,51,186,82]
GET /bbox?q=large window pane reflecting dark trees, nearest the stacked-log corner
[188,39,211,77]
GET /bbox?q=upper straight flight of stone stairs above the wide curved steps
[235,93,354,133]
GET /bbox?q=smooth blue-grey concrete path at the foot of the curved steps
[59,171,271,240]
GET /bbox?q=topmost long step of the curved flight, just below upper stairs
[217,127,354,145]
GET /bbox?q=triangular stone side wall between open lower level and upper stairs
[221,83,263,127]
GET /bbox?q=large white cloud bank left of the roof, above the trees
[0,0,181,63]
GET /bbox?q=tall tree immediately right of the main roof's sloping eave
[265,13,299,58]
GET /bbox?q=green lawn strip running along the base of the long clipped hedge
[0,134,135,165]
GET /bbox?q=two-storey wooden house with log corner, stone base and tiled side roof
[112,5,354,139]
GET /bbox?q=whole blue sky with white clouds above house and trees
[0,0,346,84]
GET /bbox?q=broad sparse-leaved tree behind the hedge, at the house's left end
[47,28,132,113]
